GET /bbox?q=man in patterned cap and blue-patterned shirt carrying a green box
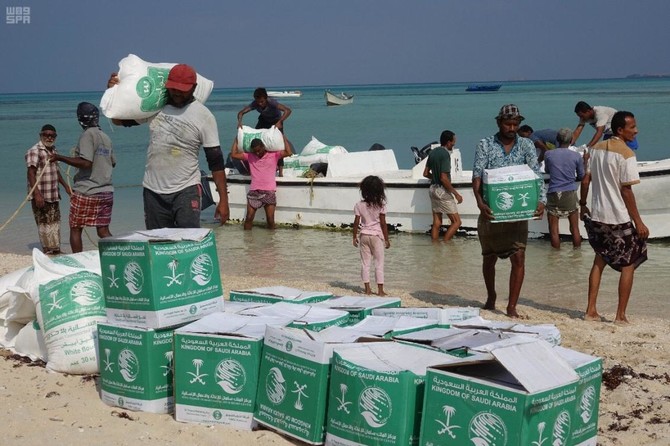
[472,104,547,318]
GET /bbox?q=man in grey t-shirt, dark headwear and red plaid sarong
[51,102,116,252]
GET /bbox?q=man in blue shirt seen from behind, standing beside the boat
[544,128,584,249]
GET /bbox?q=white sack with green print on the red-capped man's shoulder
[100,54,214,119]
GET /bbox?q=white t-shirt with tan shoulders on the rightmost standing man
[588,137,640,225]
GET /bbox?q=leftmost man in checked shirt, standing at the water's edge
[25,124,72,254]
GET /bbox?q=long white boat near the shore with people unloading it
[209,149,670,238]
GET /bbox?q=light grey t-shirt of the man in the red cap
[142,101,220,194]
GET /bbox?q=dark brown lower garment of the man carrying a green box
[477,215,528,259]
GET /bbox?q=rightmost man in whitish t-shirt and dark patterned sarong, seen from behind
[579,111,649,324]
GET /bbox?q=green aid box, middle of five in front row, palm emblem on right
[254,327,388,444]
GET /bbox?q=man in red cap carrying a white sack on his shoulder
[107,64,230,229]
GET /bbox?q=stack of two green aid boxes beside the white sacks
[97,228,223,413]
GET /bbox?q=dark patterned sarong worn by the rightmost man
[584,216,647,271]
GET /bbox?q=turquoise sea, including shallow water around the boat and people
[0,78,670,316]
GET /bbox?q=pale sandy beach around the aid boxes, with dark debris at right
[0,254,670,446]
